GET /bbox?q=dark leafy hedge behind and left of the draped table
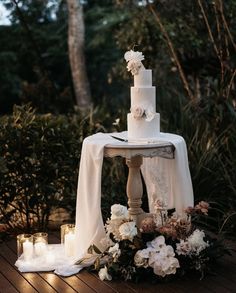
[0,105,127,230]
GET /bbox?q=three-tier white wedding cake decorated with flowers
[124,50,160,140]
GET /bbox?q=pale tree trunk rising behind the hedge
[67,0,91,109]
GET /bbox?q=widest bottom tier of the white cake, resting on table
[127,113,160,139]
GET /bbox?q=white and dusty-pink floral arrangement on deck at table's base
[79,200,228,281]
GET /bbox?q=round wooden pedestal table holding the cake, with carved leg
[104,142,175,226]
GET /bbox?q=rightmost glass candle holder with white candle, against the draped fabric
[61,224,75,257]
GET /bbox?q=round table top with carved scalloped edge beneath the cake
[104,141,175,159]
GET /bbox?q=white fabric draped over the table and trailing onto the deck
[16,132,193,276]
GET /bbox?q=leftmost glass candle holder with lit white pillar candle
[17,234,34,261]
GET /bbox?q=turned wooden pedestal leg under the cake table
[126,156,144,222]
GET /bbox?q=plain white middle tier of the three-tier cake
[130,86,156,112]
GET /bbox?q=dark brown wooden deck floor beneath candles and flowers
[0,236,236,293]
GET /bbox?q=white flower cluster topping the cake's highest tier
[124,50,144,75]
